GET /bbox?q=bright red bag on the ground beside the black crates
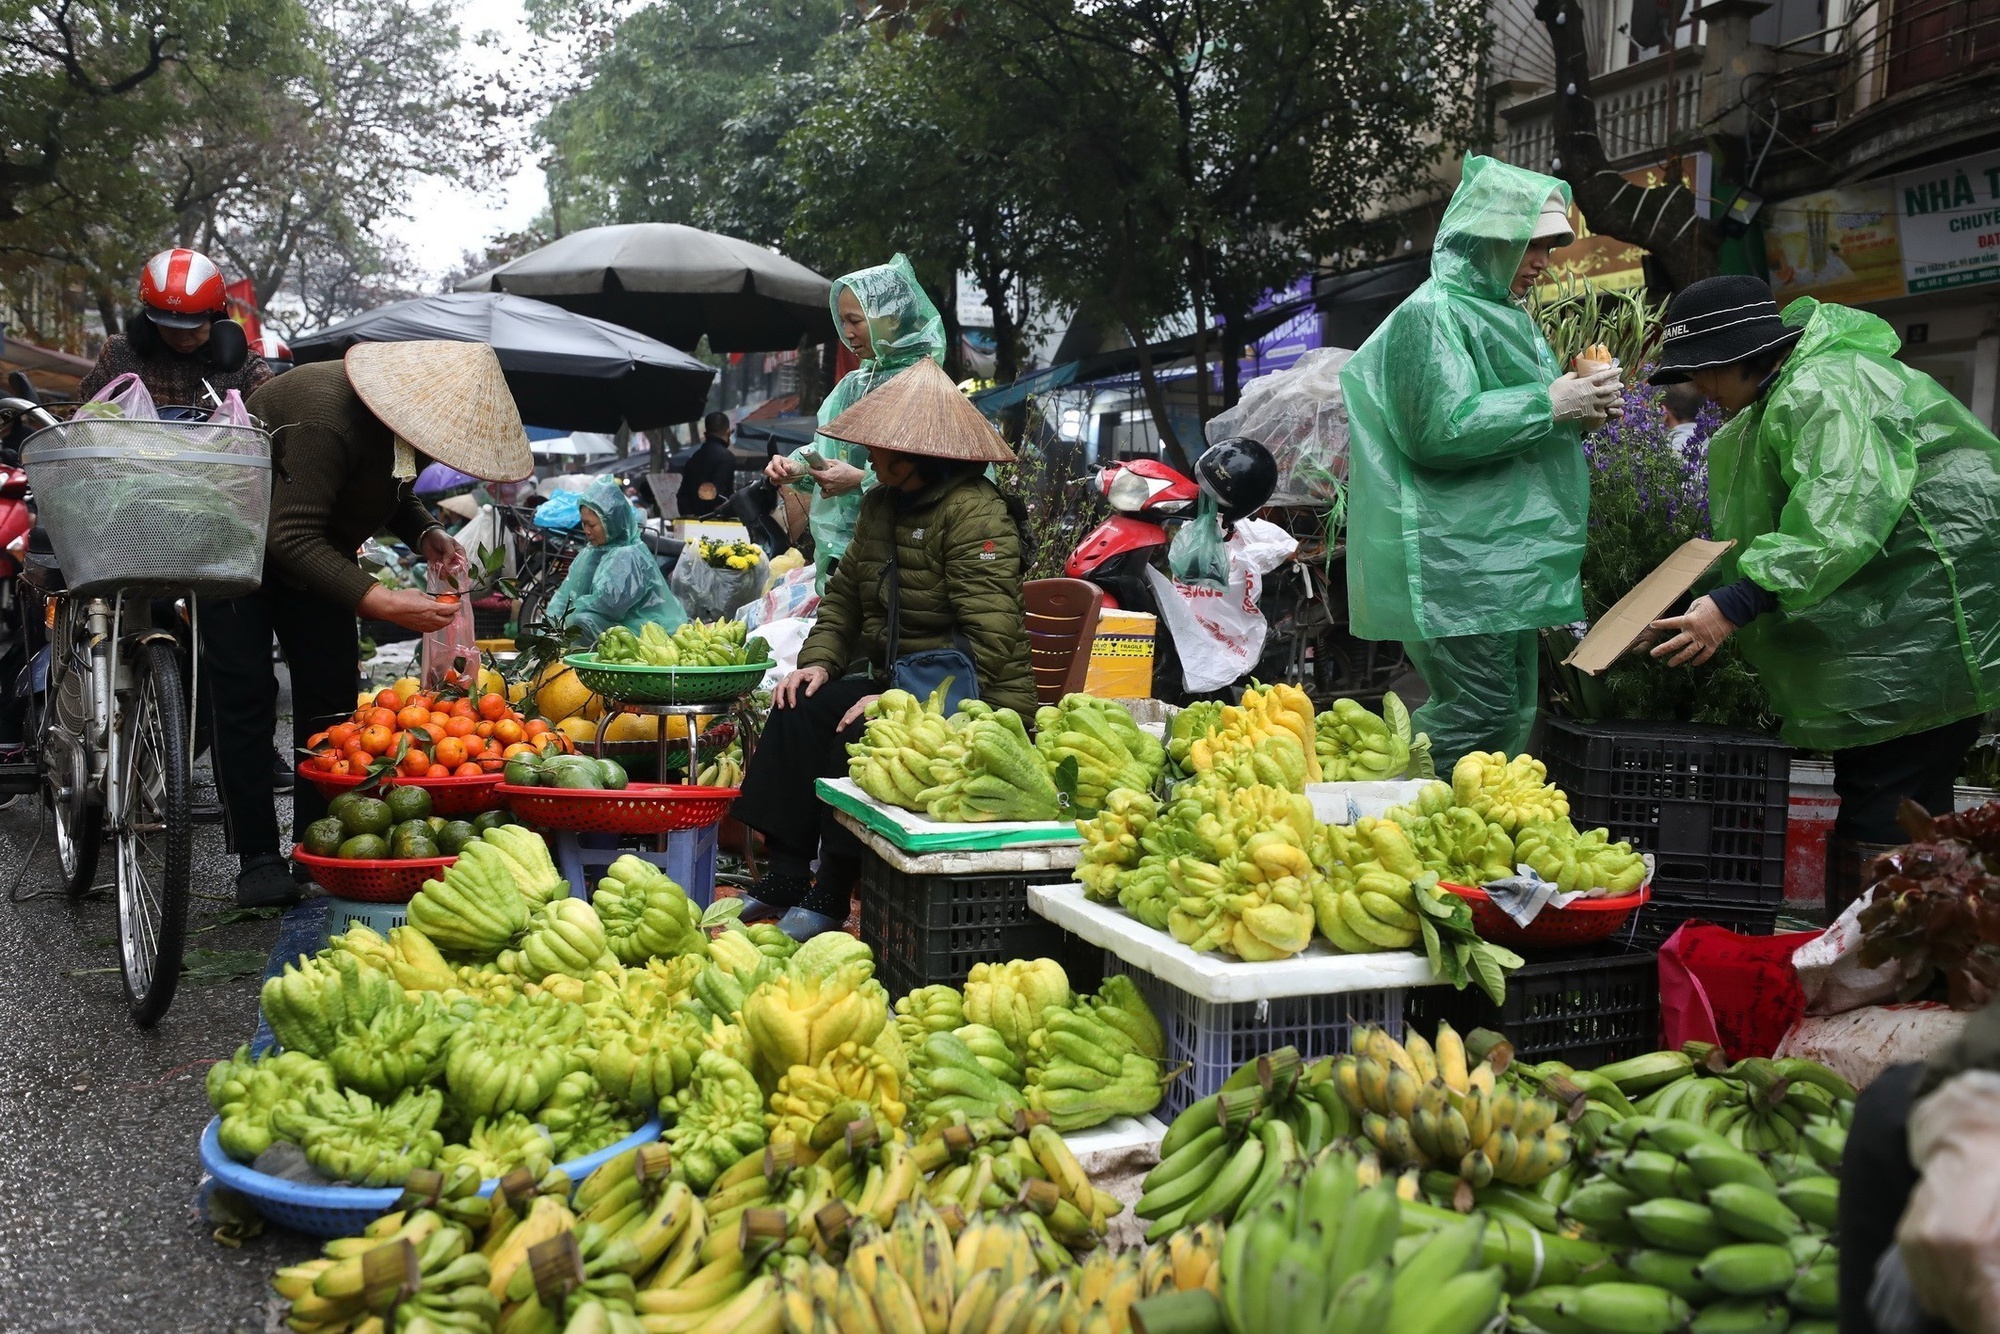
[1660,922,1820,1060]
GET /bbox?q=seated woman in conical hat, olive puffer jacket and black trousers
[732,360,1036,940]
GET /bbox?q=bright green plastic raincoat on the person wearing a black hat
[1708,296,2000,750]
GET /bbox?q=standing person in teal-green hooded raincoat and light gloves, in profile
[1340,156,1620,772]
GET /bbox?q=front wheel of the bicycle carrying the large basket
[112,640,194,1028]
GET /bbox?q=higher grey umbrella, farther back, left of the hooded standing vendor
[458,222,834,352]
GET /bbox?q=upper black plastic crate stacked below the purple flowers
[1540,718,1792,906]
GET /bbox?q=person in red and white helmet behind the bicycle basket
[76,246,282,408]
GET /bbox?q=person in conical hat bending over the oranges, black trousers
[202,342,534,906]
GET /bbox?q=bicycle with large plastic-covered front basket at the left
[0,400,270,1028]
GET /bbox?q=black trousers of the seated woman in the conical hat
[730,676,882,862]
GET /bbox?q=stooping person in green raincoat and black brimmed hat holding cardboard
[1652,276,2000,880]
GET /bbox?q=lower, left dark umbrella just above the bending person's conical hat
[292,292,716,432]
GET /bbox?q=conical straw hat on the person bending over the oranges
[346,340,534,482]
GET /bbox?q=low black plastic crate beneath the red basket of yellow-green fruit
[1402,946,1660,1070]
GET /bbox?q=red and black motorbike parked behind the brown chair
[1062,458,1408,708]
